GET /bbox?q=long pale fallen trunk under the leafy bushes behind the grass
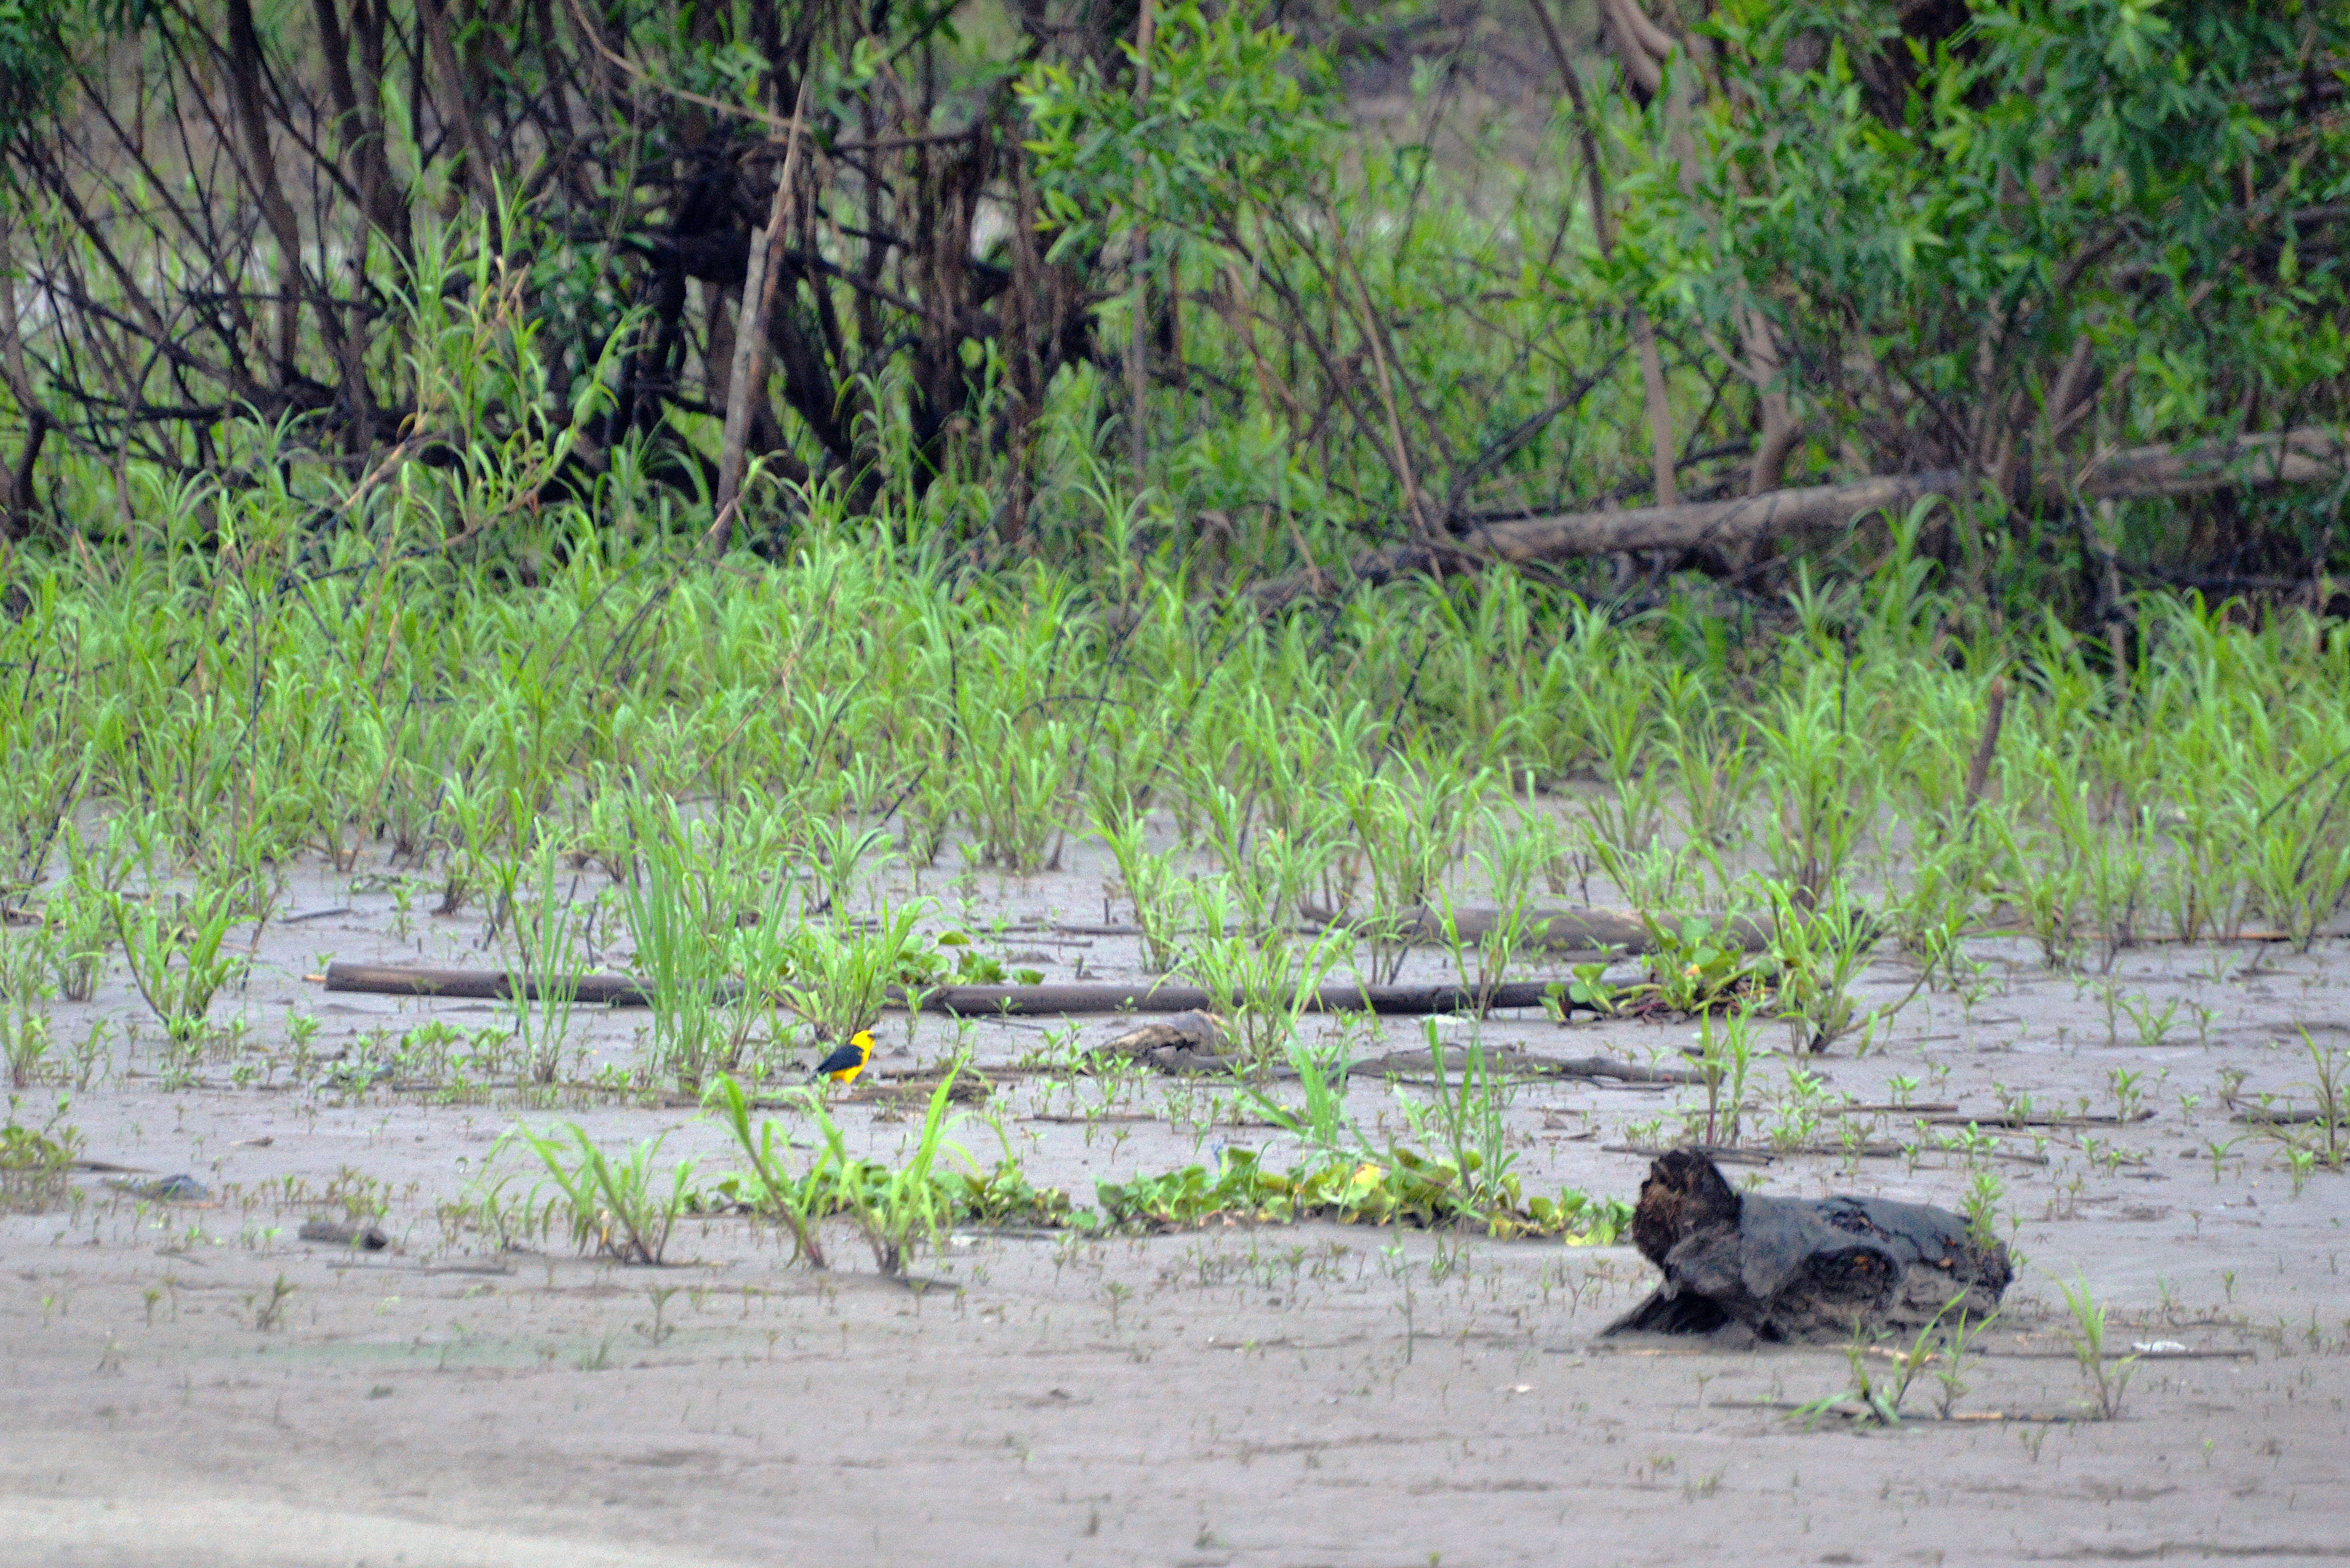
[1248,426,2350,611]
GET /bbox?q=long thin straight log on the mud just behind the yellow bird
[324,964,1563,1018]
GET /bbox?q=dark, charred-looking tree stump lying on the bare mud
[1605,1150,2014,1340]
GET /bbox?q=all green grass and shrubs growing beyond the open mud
[0,0,2350,1114]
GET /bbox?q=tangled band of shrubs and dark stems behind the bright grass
[0,0,2350,597]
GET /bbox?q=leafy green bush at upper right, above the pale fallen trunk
[1624,0,2350,479]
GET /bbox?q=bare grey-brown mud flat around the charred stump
[0,863,2350,1568]
